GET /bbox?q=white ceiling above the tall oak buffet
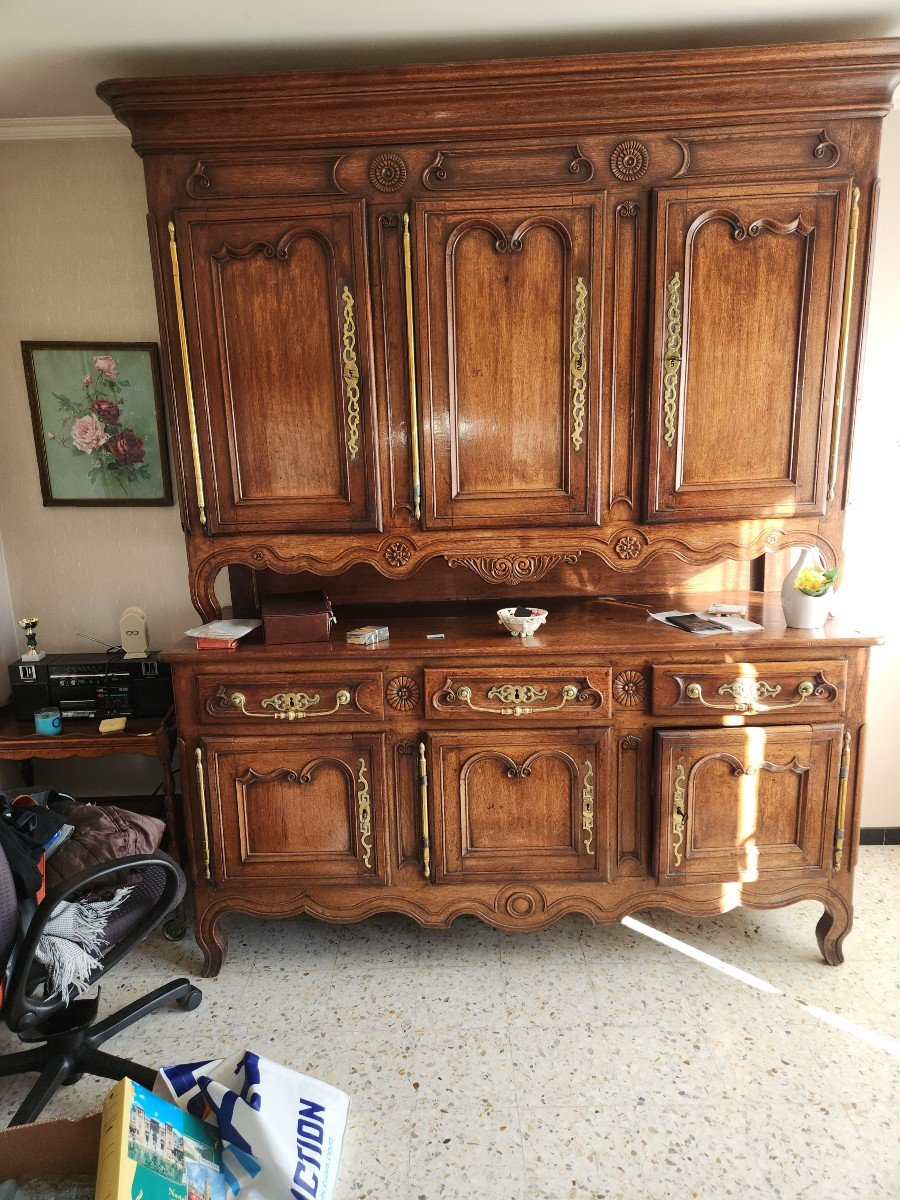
[0,0,900,119]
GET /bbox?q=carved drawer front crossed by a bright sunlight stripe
[653,660,847,720]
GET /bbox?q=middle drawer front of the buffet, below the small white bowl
[425,667,611,725]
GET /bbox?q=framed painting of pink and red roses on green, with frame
[22,342,172,505]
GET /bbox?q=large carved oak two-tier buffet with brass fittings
[100,41,900,972]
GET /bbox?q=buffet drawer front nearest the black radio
[197,670,384,731]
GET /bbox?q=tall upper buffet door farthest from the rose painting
[648,181,850,520]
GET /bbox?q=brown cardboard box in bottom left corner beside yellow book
[0,1112,102,1183]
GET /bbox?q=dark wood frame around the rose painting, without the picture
[20,341,173,508]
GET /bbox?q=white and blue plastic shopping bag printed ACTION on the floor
[154,1051,350,1200]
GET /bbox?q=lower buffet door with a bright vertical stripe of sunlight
[655,725,842,883]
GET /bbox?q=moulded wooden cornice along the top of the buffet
[97,38,900,155]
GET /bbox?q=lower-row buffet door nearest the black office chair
[200,733,388,883]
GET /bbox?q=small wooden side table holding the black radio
[0,708,185,940]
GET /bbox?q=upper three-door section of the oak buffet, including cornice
[100,40,900,576]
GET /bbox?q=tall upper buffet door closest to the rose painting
[175,200,378,533]
